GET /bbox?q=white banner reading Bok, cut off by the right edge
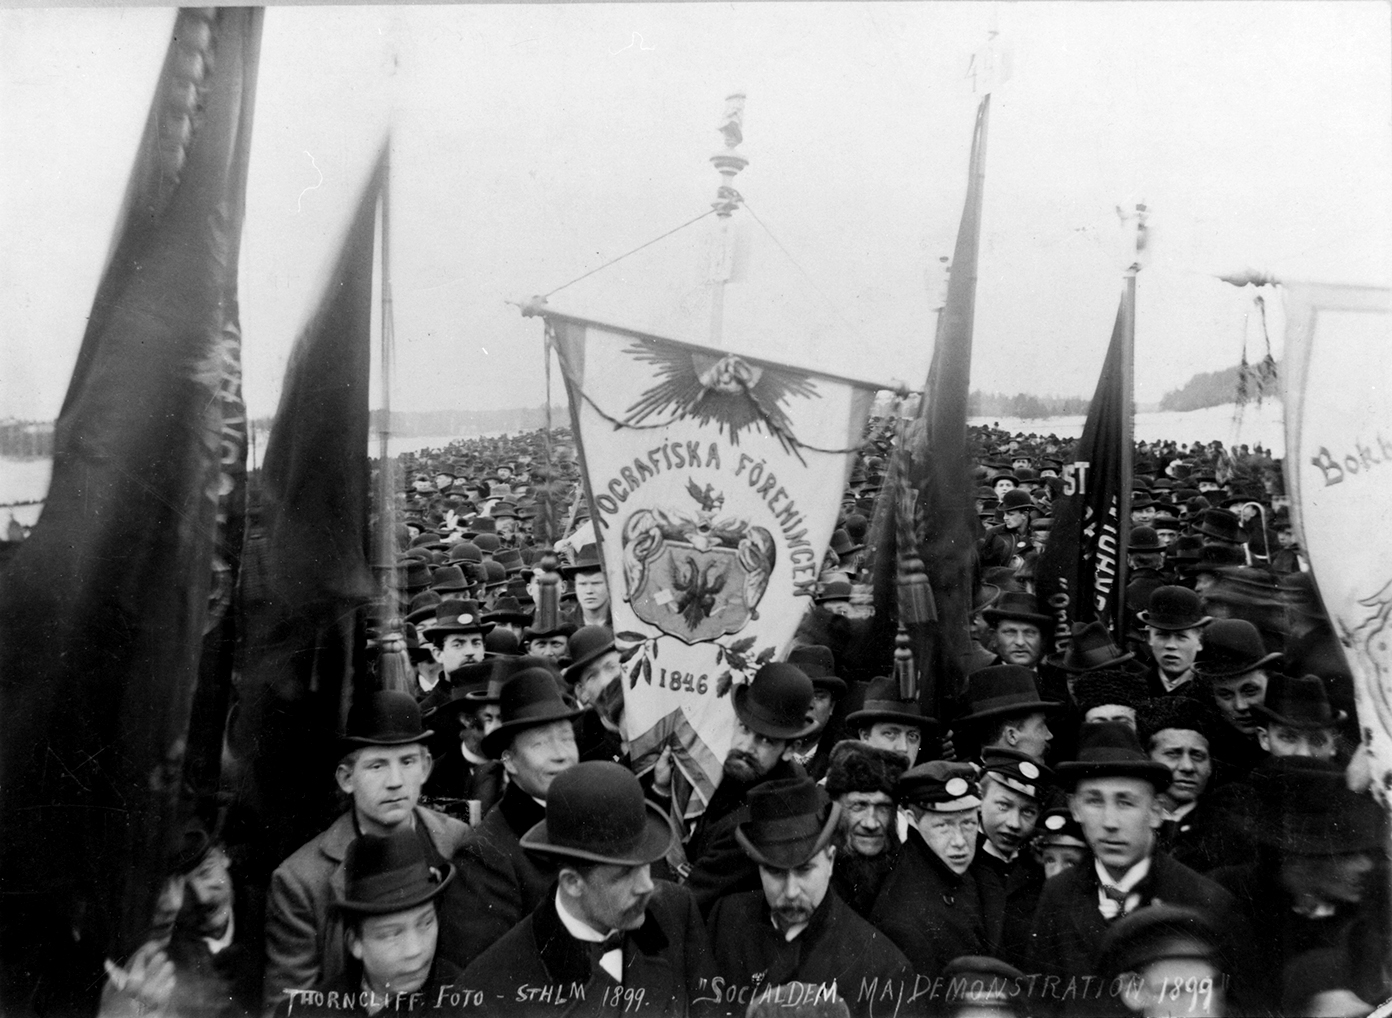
[1282,284,1392,804]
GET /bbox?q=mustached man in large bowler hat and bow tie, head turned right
[462,760,715,1018]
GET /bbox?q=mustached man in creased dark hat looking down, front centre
[710,777,915,1018]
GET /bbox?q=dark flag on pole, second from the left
[231,149,384,876]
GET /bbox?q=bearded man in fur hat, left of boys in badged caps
[827,739,905,916]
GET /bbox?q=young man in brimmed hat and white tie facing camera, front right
[1030,721,1239,1017]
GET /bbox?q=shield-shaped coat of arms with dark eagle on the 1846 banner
[622,479,778,643]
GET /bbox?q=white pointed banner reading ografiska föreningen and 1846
[547,316,874,813]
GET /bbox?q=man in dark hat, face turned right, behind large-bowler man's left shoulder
[451,667,580,966]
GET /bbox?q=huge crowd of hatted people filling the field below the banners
[95,428,1392,1018]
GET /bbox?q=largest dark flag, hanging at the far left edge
[0,8,262,1014]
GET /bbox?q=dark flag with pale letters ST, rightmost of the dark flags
[1034,276,1136,655]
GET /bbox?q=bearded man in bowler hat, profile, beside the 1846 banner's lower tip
[682,661,816,916]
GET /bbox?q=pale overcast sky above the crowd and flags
[0,1,1392,418]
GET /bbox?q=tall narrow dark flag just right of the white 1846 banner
[908,95,991,717]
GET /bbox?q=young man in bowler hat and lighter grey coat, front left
[264,692,468,1004]
